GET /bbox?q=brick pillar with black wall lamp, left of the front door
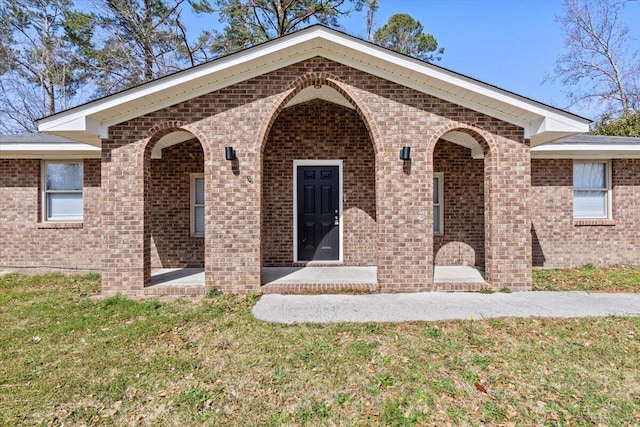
[205,123,262,294]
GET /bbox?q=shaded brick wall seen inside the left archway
[149,139,204,268]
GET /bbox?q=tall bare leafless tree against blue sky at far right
[551,0,640,115]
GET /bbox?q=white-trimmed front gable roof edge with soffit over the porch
[38,25,590,146]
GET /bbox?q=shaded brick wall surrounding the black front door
[262,100,377,266]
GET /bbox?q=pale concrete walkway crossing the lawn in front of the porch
[253,292,640,323]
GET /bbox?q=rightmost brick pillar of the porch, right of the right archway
[485,138,531,290]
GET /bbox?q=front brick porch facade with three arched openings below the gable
[102,58,531,293]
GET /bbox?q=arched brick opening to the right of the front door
[428,123,498,290]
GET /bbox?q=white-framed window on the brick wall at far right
[573,161,611,218]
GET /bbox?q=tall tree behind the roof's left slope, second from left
[95,0,190,95]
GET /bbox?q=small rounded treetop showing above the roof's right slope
[373,13,444,62]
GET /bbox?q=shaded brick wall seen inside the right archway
[433,140,484,268]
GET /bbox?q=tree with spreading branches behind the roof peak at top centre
[193,0,364,55]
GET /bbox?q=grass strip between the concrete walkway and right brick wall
[533,264,640,292]
